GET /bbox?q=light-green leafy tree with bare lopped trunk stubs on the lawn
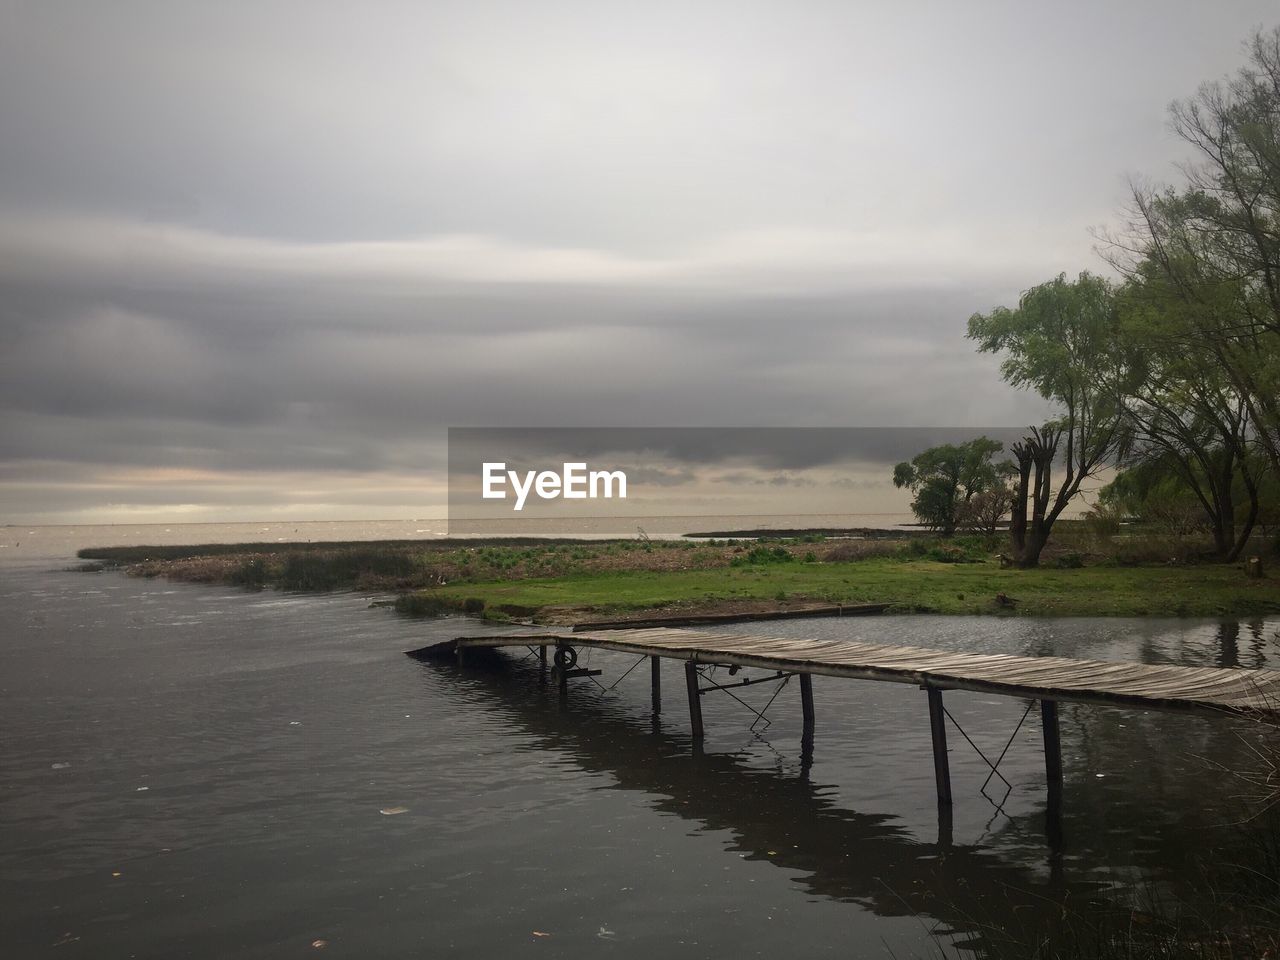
[969,273,1126,567]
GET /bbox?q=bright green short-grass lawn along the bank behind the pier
[428,558,1280,617]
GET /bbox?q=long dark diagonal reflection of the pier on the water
[421,654,1126,942]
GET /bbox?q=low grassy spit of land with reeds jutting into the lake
[81,538,1280,622]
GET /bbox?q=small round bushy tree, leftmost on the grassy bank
[893,436,1007,536]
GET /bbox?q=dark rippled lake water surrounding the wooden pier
[0,529,1280,960]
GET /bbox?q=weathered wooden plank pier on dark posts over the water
[410,627,1280,829]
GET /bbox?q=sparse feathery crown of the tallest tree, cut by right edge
[1105,28,1280,481]
